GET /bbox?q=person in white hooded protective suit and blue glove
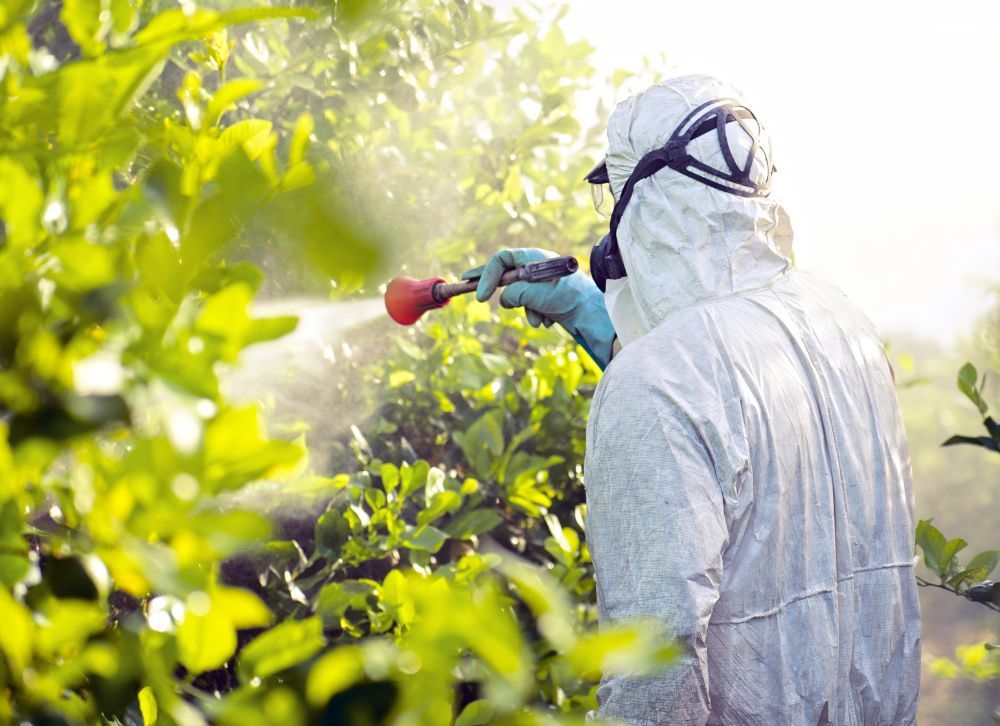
[467,76,920,726]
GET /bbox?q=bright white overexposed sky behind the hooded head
[497,0,1000,344]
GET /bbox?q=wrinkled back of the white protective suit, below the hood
[584,273,919,724]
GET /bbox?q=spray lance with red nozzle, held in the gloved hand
[385,257,580,325]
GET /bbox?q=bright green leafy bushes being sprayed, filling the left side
[0,0,676,725]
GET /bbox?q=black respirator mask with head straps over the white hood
[584,98,775,293]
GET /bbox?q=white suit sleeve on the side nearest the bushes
[585,381,729,726]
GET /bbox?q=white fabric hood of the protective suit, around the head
[606,75,791,345]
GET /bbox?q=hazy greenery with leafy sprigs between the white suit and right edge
[901,320,1000,725]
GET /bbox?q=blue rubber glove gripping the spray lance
[462,248,615,370]
